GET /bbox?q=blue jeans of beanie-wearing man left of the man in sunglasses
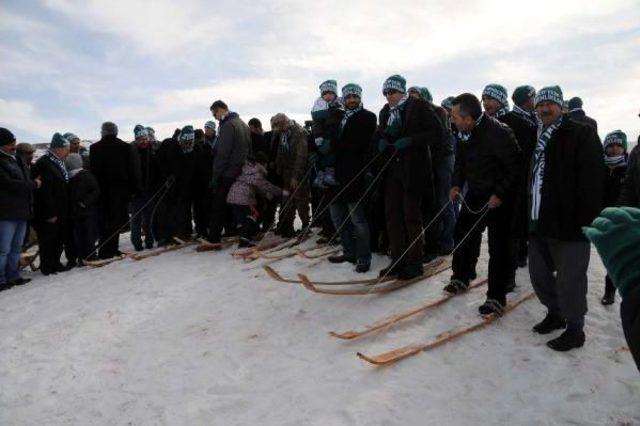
[330,201,371,263]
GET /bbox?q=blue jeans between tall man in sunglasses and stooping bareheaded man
[433,154,458,252]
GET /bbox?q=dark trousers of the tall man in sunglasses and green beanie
[384,164,424,267]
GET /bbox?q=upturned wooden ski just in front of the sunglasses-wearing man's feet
[298,259,451,296]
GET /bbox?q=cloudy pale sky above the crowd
[0,0,640,145]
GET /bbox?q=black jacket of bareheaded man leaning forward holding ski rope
[453,115,520,201]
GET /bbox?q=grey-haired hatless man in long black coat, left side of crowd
[89,122,140,259]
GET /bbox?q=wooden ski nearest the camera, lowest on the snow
[357,292,534,365]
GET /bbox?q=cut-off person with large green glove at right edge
[583,207,640,370]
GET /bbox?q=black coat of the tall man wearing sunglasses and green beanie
[373,98,444,194]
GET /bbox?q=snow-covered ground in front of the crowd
[0,238,640,425]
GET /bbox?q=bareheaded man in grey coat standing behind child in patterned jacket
[209,101,251,243]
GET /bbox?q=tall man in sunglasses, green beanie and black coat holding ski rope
[375,75,444,280]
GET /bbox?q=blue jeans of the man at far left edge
[0,220,27,284]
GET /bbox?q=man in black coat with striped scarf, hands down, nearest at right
[529,86,605,351]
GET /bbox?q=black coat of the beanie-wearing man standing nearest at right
[535,115,605,241]
